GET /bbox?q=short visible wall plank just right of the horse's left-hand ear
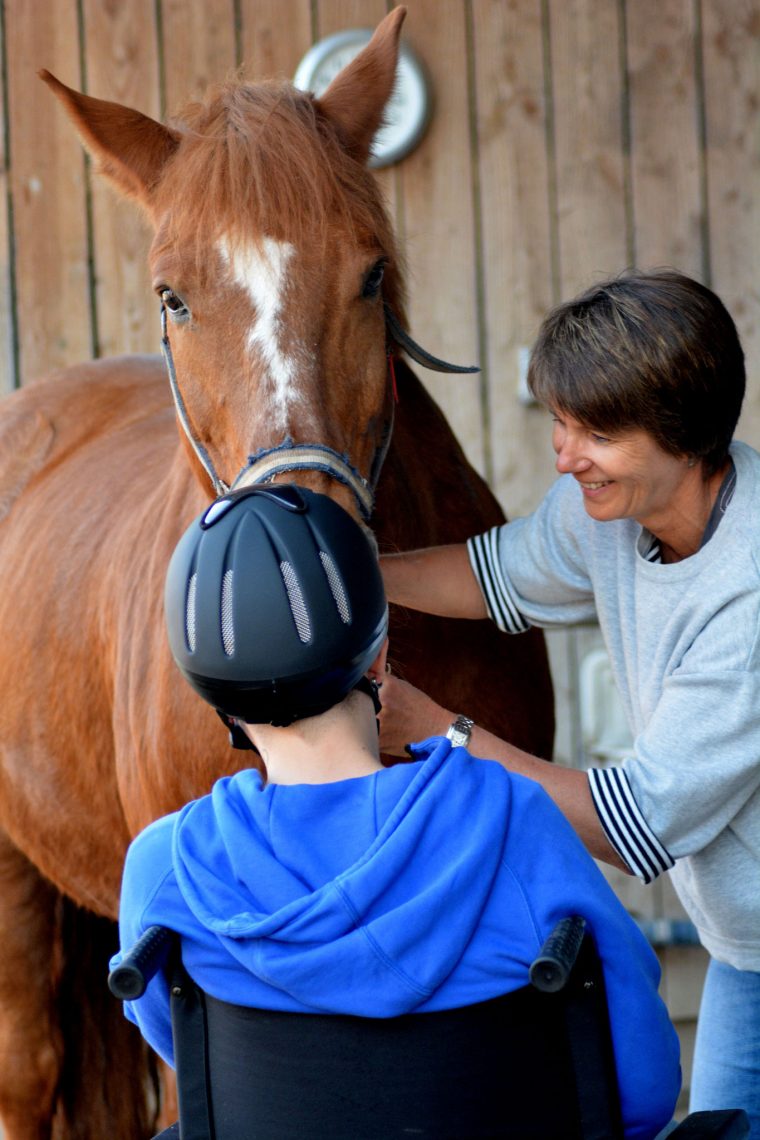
[161,0,237,114]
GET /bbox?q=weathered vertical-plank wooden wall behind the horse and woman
[5,0,760,514]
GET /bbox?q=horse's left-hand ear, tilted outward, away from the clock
[38,71,180,207]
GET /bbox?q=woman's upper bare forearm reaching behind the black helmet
[379,543,488,618]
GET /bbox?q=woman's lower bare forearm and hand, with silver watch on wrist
[379,675,630,874]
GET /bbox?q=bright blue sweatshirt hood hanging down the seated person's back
[173,738,510,1017]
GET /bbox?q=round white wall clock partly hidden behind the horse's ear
[294,29,430,168]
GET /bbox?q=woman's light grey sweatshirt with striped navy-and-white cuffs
[468,443,760,970]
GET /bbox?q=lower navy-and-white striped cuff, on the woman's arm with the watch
[588,767,675,882]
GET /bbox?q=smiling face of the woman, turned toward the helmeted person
[551,412,698,534]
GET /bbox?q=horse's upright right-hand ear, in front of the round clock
[317,7,407,162]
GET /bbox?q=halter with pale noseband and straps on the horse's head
[161,302,480,521]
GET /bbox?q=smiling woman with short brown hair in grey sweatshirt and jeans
[382,271,760,1137]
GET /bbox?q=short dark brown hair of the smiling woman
[528,270,745,475]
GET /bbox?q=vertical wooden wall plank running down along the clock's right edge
[398,0,485,473]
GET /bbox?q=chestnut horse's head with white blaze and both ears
[41,8,406,516]
